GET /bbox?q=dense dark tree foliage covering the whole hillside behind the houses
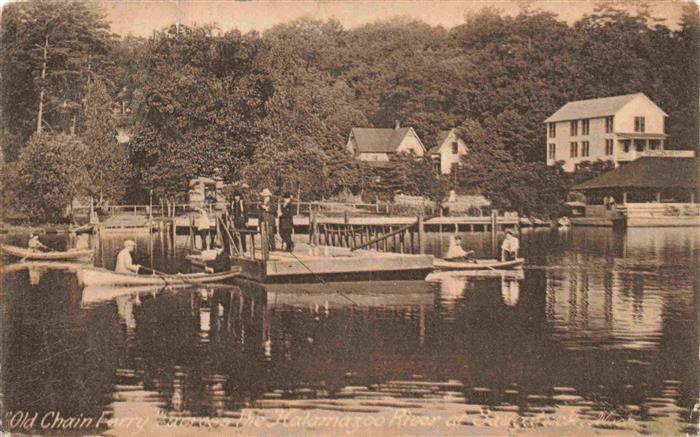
[0,0,700,215]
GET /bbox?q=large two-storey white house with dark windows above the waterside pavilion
[544,93,694,172]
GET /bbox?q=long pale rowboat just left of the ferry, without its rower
[78,267,241,286]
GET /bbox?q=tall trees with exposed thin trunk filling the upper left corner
[0,0,112,160]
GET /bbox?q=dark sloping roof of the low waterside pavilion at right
[572,157,700,190]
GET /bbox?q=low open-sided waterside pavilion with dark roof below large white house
[572,157,700,226]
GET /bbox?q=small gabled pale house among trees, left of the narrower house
[346,122,426,166]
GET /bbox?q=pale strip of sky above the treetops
[100,0,683,36]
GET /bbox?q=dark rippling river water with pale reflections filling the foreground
[0,228,700,436]
